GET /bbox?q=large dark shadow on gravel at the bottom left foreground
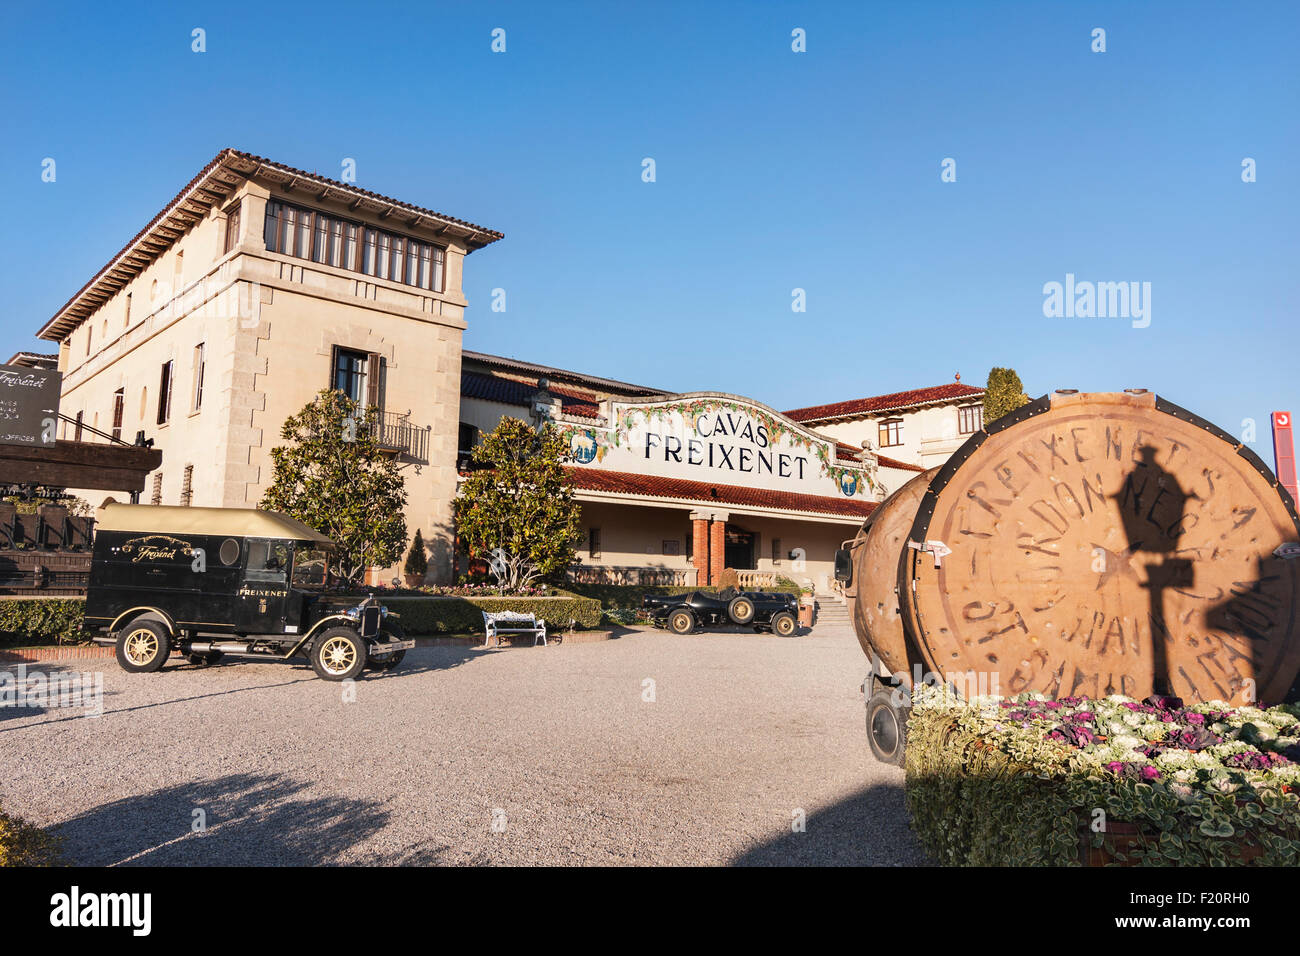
[55,774,389,866]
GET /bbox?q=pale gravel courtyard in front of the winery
[0,627,922,865]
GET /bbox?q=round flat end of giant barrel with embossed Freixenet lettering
[898,393,1300,704]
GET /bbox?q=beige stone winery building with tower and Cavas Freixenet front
[27,150,983,591]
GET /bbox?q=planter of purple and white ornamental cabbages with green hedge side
[906,688,1300,866]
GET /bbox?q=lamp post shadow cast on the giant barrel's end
[1109,445,1197,695]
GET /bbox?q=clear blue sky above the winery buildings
[0,1,1300,464]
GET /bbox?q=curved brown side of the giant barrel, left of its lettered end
[852,468,939,675]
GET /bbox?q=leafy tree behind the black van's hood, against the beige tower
[260,389,407,581]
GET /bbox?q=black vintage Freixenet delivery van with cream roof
[85,503,415,680]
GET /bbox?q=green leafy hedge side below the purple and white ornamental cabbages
[905,698,1300,866]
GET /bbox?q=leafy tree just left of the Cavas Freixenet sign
[452,418,581,591]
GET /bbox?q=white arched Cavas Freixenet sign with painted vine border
[559,395,875,498]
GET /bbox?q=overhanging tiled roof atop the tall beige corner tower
[36,148,502,341]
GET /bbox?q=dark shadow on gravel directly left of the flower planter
[732,786,927,866]
